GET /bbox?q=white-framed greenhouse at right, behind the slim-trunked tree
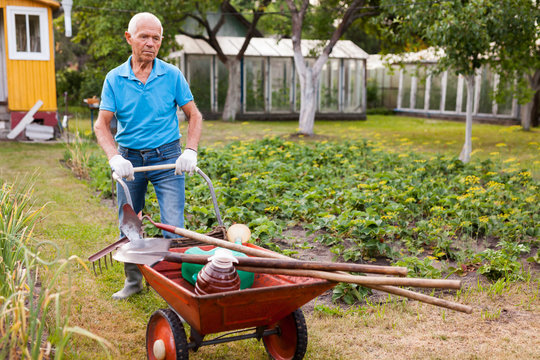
[368,50,519,123]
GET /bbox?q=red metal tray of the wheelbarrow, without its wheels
[138,244,336,335]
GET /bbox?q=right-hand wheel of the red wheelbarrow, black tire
[263,309,307,360]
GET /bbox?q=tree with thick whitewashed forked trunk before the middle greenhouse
[285,0,377,136]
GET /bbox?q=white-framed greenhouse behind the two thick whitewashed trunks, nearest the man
[170,35,368,119]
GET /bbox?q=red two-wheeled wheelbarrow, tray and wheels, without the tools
[138,244,336,360]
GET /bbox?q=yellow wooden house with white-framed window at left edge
[0,0,60,138]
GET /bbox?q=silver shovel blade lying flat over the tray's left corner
[113,238,171,265]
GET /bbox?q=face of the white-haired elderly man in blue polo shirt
[126,19,162,62]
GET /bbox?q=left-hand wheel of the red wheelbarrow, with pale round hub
[146,309,189,360]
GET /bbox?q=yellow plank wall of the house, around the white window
[0,0,57,111]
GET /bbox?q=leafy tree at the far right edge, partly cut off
[490,0,540,130]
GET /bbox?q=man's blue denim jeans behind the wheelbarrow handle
[116,141,185,238]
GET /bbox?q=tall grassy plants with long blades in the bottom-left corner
[0,182,108,359]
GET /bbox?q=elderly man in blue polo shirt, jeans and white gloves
[94,13,202,300]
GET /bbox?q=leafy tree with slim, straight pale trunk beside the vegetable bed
[381,0,493,163]
